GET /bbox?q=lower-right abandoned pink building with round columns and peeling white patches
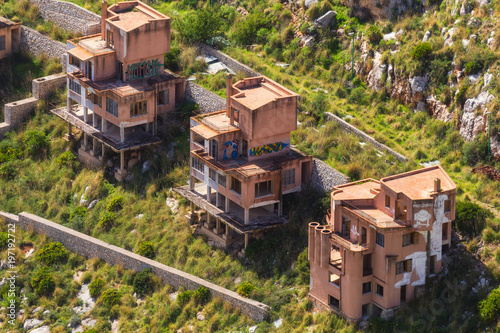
[309,166,456,320]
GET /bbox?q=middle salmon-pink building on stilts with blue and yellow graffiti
[176,74,312,246]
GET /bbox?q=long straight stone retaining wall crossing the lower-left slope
[0,212,269,321]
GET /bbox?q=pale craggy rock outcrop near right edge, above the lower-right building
[460,91,494,142]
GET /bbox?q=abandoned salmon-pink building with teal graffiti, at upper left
[52,1,186,180]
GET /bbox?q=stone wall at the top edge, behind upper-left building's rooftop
[30,0,101,36]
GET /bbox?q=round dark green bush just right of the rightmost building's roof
[454,201,491,237]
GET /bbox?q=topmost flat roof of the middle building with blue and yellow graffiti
[231,76,298,110]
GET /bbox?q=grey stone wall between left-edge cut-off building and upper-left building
[19,25,66,72]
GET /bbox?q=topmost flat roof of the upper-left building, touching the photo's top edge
[106,1,170,31]
